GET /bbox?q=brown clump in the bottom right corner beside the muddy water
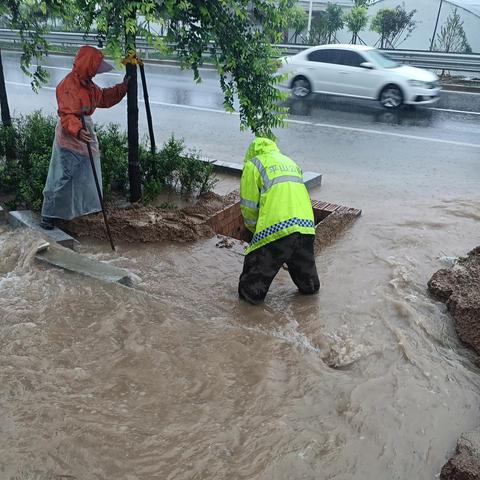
[440,431,480,480]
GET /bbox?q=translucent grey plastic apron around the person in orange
[42,116,102,220]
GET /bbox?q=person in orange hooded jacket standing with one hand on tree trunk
[41,46,129,229]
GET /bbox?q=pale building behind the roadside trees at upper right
[298,0,480,53]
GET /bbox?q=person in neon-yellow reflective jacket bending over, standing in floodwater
[238,138,320,304]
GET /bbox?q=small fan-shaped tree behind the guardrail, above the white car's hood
[371,5,417,48]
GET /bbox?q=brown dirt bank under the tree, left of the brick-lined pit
[61,192,236,243]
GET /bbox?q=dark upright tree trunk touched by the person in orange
[126,12,142,203]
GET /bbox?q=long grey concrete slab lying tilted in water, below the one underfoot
[35,246,138,287]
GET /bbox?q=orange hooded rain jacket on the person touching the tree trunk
[56,45,127,137]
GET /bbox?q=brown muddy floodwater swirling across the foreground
[0,183,480,480]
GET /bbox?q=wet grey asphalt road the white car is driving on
[3,52,480,205]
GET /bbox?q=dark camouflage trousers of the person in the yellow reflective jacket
[238,233,320,305]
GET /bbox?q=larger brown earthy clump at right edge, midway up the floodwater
[428,246,480,356]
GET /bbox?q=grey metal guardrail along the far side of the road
[0,29,480,73]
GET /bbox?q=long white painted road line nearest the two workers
[5,81,480,148]
